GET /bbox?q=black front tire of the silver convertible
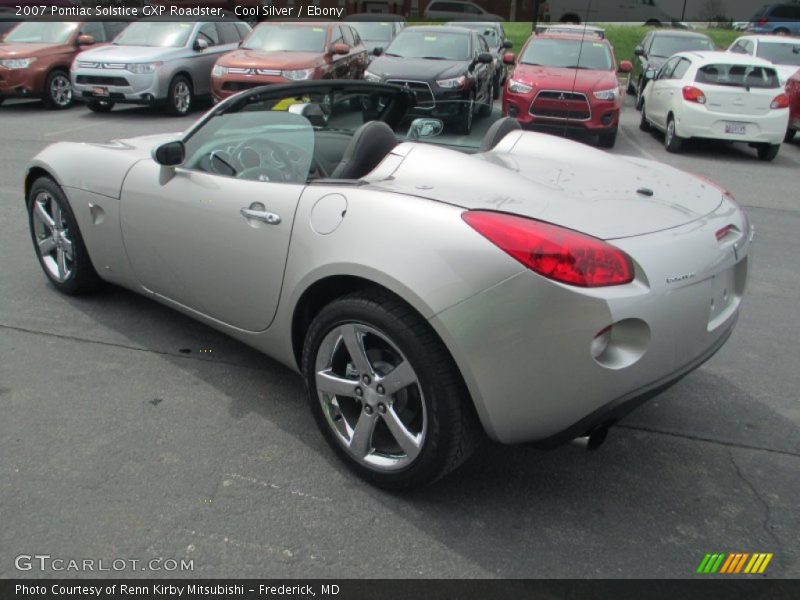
[26,177,101,295]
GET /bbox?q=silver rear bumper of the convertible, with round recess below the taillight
[431,202,752,446]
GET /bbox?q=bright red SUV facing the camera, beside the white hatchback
[503,34,631,148]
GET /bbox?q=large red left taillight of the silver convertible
[461,210,634,287]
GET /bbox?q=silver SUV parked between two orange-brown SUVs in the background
[72,19,250,115]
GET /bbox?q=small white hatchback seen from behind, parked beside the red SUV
[639,52,789,160]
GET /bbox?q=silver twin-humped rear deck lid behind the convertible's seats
[367,132,722,240]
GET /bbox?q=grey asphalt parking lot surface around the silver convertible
[0,98,800,578]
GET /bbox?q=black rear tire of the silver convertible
[301,290,484,490]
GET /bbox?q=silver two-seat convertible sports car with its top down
[25,81,753,489]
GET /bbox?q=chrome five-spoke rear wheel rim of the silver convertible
[314,323,428,471]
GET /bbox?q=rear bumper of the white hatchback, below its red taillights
[675,102,789,144]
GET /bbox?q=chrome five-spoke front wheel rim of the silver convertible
[33,192,74,283]
